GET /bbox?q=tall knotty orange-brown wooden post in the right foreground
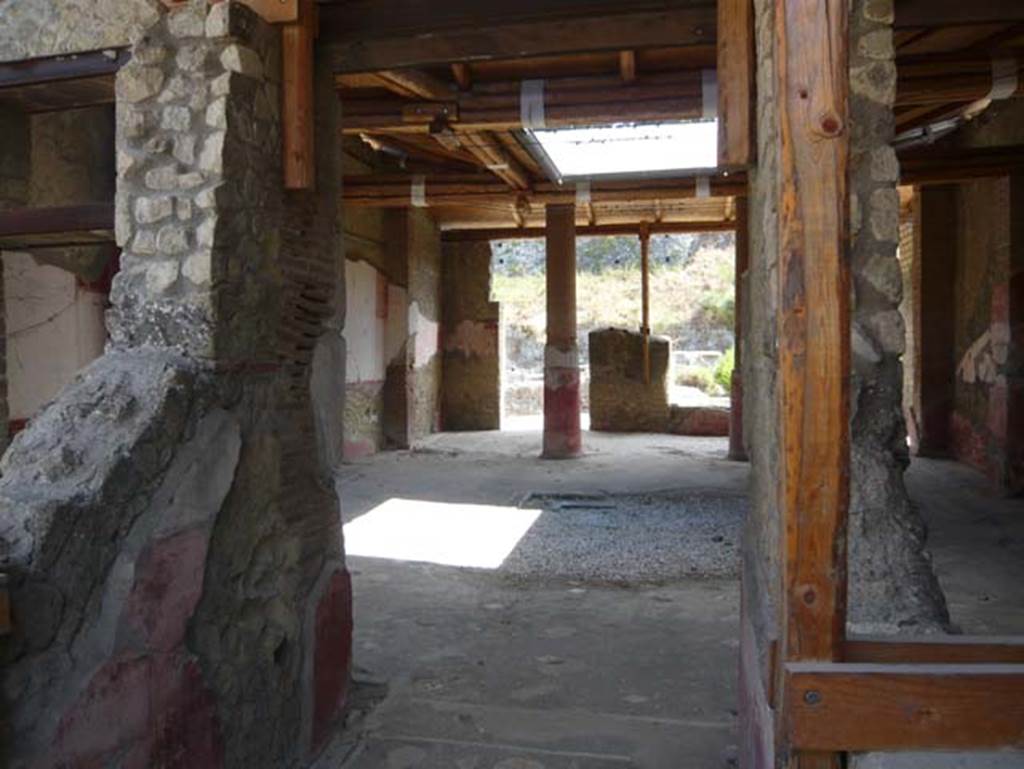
[775,0,850,769]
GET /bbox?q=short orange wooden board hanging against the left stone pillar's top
[281,0,316,189]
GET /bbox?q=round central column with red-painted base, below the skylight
[544,205,582,459]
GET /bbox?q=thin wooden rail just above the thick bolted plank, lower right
[843,636,1024,665]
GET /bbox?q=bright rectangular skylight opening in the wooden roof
[530,120,718,179]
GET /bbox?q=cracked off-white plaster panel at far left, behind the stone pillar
[3,252,106,420]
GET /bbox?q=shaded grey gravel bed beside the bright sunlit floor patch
[501,490,748,584]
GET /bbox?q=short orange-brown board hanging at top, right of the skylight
[718,0,754,167]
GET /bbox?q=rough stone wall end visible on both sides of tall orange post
[739,0,947,769]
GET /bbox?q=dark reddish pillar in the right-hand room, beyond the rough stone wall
[913,185,958,457]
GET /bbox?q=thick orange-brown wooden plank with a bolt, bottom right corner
[785,663,1024,752]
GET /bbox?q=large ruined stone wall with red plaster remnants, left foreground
[0,2,351,769]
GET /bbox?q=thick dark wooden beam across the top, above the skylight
[325,6,716,73]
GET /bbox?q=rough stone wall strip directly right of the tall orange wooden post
[848,0,948,633]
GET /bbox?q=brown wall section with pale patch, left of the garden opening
[441,242,502,430]
